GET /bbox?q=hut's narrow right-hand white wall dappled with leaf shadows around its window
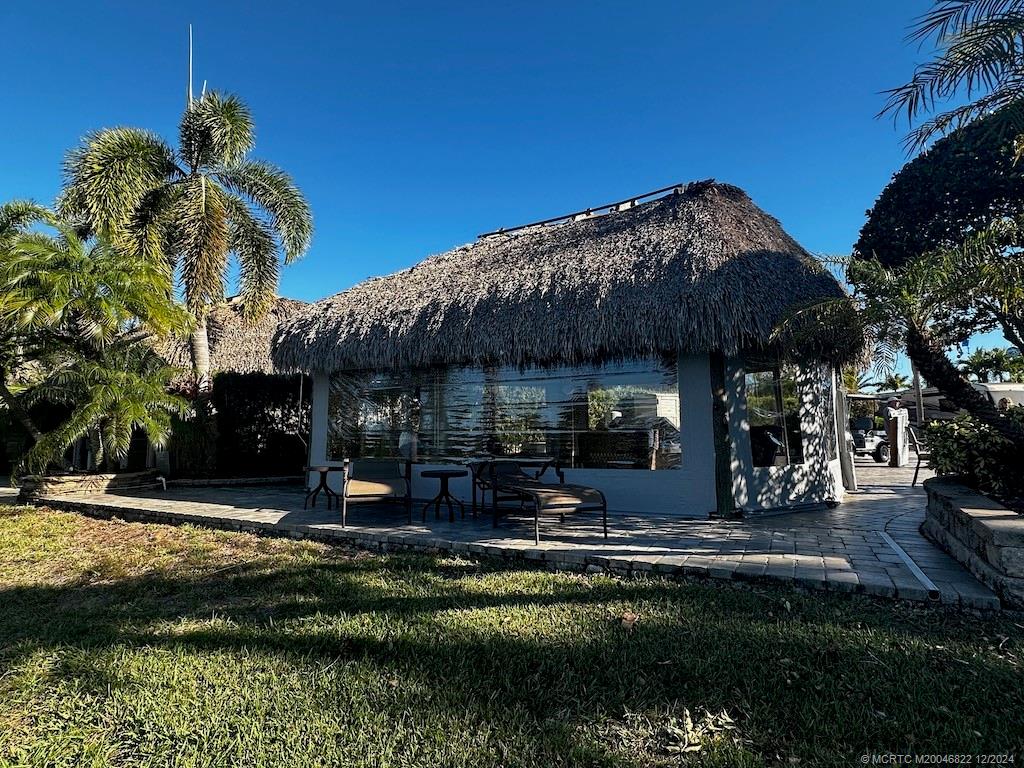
[726,358,844,511]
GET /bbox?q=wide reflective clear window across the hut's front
[330,360,681,469]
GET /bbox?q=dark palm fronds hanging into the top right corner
[881,0,1024,157]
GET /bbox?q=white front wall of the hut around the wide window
[308,354,716,518]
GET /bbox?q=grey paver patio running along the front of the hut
[32,463,999,608]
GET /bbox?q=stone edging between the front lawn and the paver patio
[35,498,999,610]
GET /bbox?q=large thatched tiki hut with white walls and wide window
[272,181,845,516]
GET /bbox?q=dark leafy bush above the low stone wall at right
[927,406,1024,499]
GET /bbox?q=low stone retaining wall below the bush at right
[922,477,1024,608]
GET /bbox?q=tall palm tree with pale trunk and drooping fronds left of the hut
[59,92,312,392]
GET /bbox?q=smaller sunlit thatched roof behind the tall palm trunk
[157,297,309,374]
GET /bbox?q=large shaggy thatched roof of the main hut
[272,181,844,372]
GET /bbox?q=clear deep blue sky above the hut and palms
[0,0,996,364]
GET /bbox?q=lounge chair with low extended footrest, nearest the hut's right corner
[486,461,608,544]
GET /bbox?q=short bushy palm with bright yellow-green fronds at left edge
[0,222,190,471]
